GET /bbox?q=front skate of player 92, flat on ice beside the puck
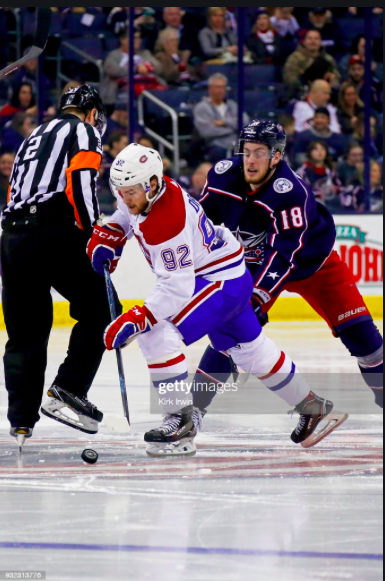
[144,406,205,458]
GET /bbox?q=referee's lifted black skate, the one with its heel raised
[41,385,103,434]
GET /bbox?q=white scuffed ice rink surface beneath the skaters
[0,323,383,581]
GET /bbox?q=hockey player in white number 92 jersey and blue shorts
[88,144,347,456]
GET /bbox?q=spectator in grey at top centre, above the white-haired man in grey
[199,7,238,62]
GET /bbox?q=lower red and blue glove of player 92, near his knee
[104,307,157,351]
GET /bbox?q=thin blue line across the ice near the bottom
[0,542,384,561]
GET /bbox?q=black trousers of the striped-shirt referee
[1,218,122,428]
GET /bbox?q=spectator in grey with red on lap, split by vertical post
[100,29,161,108]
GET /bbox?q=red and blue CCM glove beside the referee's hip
[87,223,127,276]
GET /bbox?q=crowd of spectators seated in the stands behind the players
[0,7,383,212]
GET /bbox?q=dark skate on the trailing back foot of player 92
[291,391,349,448]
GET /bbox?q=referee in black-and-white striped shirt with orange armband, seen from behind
[1,85,121,442]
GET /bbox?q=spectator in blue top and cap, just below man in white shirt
[294,107,346,165]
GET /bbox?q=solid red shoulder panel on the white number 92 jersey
[140,178,186,246]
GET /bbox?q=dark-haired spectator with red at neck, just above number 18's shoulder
[298,141,341,209]
